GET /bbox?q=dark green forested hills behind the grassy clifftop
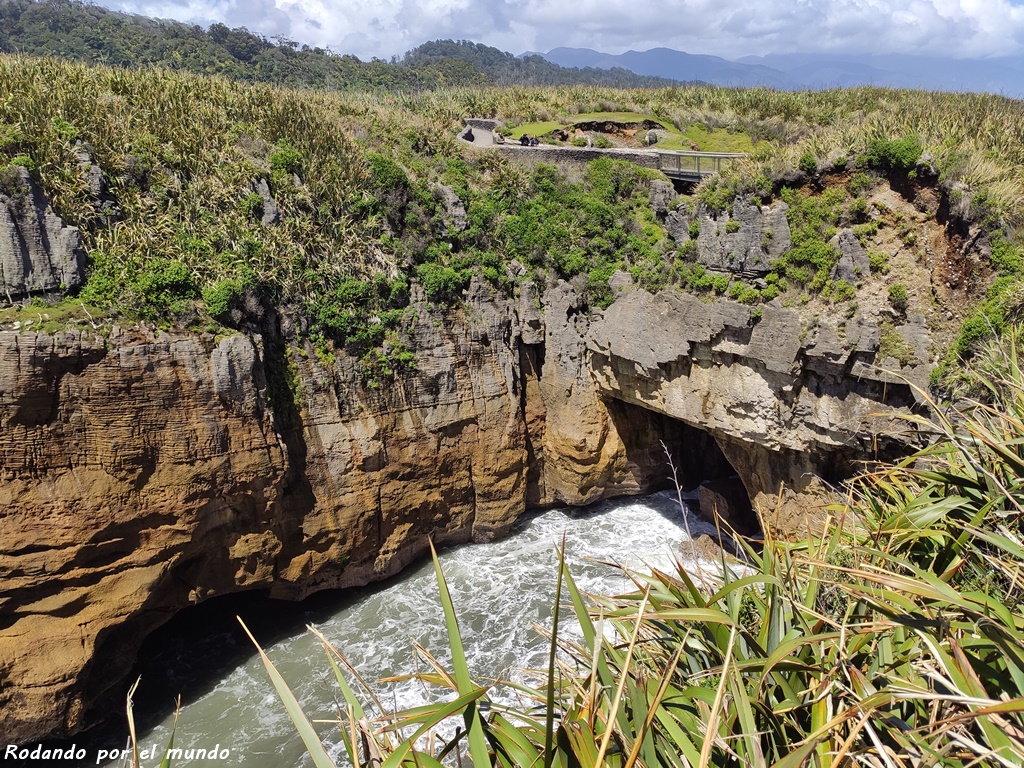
[0,0,671,91]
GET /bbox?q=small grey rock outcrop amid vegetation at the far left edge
[0,166,85,306]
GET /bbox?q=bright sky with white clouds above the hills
[98,0,1024,58]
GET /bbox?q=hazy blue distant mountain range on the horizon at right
[523,48,1024,97]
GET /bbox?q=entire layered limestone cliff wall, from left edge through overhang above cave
[0,281,923,741]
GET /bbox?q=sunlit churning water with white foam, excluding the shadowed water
[97,493,714,768]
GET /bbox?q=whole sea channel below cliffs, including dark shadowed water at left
[78,492,713,768]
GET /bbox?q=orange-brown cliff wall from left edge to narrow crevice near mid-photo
[0,286,526,741]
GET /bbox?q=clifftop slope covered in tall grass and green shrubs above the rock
[0,56,1024,382]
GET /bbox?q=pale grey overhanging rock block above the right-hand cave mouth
[587,291,930,537]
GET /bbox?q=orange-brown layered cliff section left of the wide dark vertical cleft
[0,333,287,739]
